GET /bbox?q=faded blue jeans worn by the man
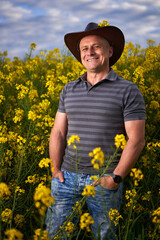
[46,170,123,240]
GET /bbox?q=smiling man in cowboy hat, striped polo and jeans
[46,23,145,240]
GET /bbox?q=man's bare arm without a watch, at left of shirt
[49,112,67,182]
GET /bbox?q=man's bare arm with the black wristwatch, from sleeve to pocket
[97,120,145,189]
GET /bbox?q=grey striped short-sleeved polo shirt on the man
[58,69,145,174]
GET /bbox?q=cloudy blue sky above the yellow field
[0,0,160,58]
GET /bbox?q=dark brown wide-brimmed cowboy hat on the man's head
[64,22,125,66]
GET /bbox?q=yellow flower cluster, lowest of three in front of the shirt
[89,147,104,169]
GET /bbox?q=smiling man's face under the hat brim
[79,35,113,73]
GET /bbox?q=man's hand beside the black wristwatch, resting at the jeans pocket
[93,176,119,190]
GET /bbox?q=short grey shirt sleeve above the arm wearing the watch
[123,83,146,121]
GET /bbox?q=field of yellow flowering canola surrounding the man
[0,40,160,240]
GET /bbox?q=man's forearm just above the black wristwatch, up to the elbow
[114,139,145,179]
